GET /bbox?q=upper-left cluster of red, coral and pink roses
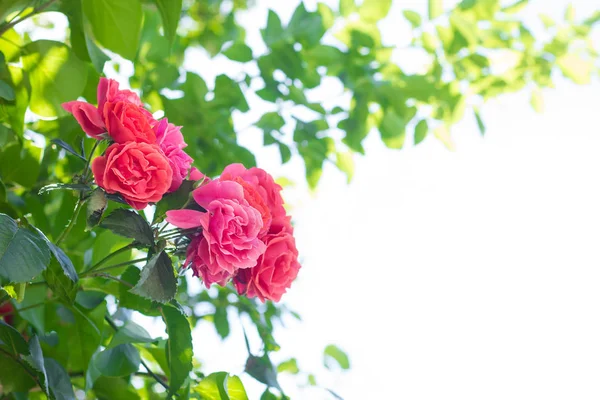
[63,78,200,210]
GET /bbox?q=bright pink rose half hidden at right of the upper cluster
[154,118,193,192]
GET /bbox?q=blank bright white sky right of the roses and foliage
[190,0,600,400]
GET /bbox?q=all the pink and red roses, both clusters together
[63,78,300,302]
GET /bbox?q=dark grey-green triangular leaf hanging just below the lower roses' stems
[130,251,177,303]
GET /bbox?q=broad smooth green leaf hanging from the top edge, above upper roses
[83,0,143,60]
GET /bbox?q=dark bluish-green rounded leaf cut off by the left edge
[0,214,50,283]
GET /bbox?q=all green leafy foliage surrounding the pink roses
[0,0,600,399]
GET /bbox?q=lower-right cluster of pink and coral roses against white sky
[167,164,300,301]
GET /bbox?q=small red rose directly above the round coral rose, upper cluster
[103,101,156,143]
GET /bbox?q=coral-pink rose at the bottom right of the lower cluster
[233,231,300,303]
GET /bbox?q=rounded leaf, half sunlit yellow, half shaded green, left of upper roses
[23,41,88,117]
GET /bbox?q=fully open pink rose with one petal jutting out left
[167,180,265,287]
